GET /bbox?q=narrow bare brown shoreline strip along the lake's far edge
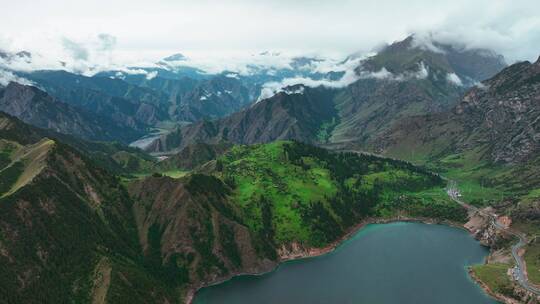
[185,216,476,304]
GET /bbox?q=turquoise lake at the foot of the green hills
[194,222,498,304]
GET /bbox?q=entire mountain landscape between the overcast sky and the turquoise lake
[0,36,540,303]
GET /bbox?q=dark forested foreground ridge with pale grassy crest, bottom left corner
[0,139,177,303]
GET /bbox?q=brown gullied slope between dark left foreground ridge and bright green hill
[129,176,276,287]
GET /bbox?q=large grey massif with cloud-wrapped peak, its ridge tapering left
[148,37,505,152]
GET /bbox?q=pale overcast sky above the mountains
[0,0,540,69]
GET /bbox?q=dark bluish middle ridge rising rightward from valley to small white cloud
[147,85,335,152]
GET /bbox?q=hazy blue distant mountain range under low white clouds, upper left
[0,44,364,143]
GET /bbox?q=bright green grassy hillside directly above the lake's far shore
[216,142,464,246]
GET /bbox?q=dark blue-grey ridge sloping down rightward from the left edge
[0,82,142,142]
